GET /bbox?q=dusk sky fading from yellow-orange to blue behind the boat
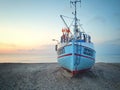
[0,0,120,62]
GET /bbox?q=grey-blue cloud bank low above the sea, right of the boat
[96,38,120,55]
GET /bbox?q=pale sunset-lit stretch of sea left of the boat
[0,53,57,63]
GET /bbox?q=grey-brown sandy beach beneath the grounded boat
[0,63,120,90]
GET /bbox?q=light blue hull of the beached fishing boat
[58,44,95,73]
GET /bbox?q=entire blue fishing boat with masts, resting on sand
[53,0,96,75]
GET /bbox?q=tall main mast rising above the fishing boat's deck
[70,0,81,39]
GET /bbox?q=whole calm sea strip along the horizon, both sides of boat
[0,54,120,63]
